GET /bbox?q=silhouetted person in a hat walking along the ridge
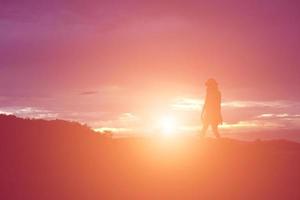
[200,78,223,138]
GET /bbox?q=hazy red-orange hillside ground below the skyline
[0,116,300,200]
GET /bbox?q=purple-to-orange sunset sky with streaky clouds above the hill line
[0,0,300,134]
